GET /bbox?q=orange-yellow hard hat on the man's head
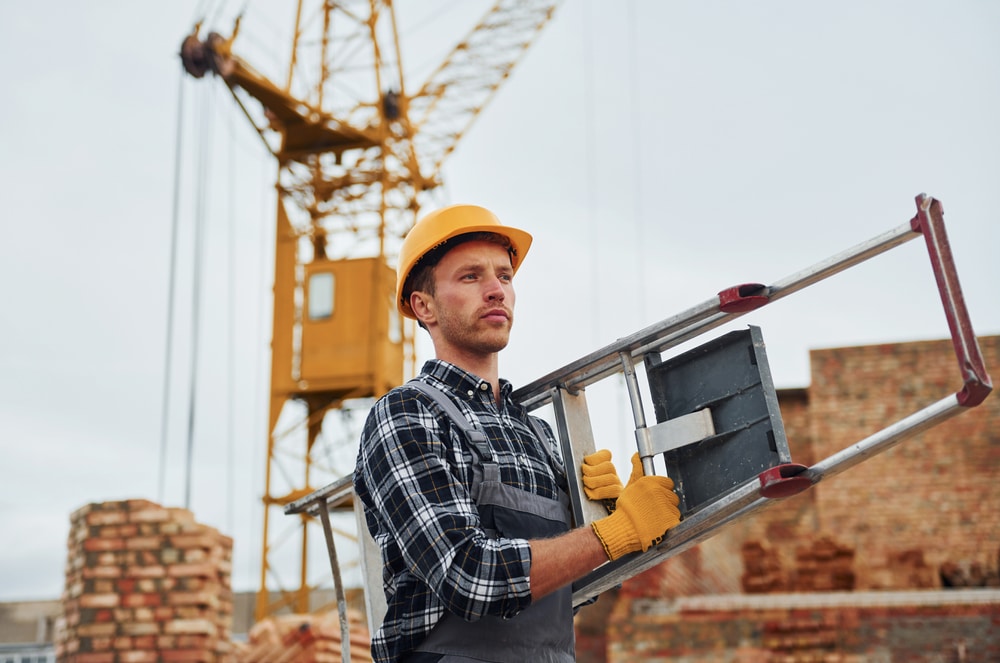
[396,205,531,319]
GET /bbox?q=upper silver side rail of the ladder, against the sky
[513,222,920,409]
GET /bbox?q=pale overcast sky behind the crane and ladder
[0,0,1000,600]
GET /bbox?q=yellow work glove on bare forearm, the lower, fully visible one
[591,470,681,560]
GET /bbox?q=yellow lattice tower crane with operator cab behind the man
[181,0,559,620]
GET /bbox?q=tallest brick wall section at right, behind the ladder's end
[809,336,1000,588]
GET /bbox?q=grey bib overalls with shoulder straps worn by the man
[407,380,576,663]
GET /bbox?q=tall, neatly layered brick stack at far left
[56,500,234,663]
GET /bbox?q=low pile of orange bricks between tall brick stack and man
[235,613,372,663]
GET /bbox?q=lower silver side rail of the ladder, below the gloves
[573,394,966,605]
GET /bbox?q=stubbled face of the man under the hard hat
[424,241,515,354]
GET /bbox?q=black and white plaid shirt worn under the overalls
[354,360,565,662]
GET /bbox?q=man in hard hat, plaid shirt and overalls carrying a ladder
[354,205,680,663]
